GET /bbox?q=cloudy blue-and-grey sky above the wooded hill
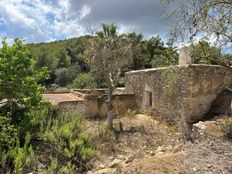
[0,0,172,43]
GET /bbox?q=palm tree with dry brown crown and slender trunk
[87,24,132,129]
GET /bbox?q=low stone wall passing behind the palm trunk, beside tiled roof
[53,89,136,118]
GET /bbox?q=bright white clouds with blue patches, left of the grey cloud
[0,0,84,42]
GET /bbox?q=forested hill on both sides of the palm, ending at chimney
[28,33,177,88]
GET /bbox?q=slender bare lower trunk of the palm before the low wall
[107,87,113,129]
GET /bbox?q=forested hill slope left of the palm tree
[28,36,90,86]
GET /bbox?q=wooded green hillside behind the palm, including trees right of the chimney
[27,33,232,90]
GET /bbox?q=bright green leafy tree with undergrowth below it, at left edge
[0,39,47,173]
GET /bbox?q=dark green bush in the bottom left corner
[0,121,37,174]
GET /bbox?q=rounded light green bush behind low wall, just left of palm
[73,73,96,89]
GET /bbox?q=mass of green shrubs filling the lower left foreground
[0,104,95,174]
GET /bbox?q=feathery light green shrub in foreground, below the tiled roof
[43,112,95,173]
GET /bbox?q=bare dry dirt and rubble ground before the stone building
[86,114,232,174]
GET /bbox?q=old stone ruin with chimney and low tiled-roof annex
[43,47,232,123]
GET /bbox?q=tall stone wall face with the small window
[125,67,185,122]
